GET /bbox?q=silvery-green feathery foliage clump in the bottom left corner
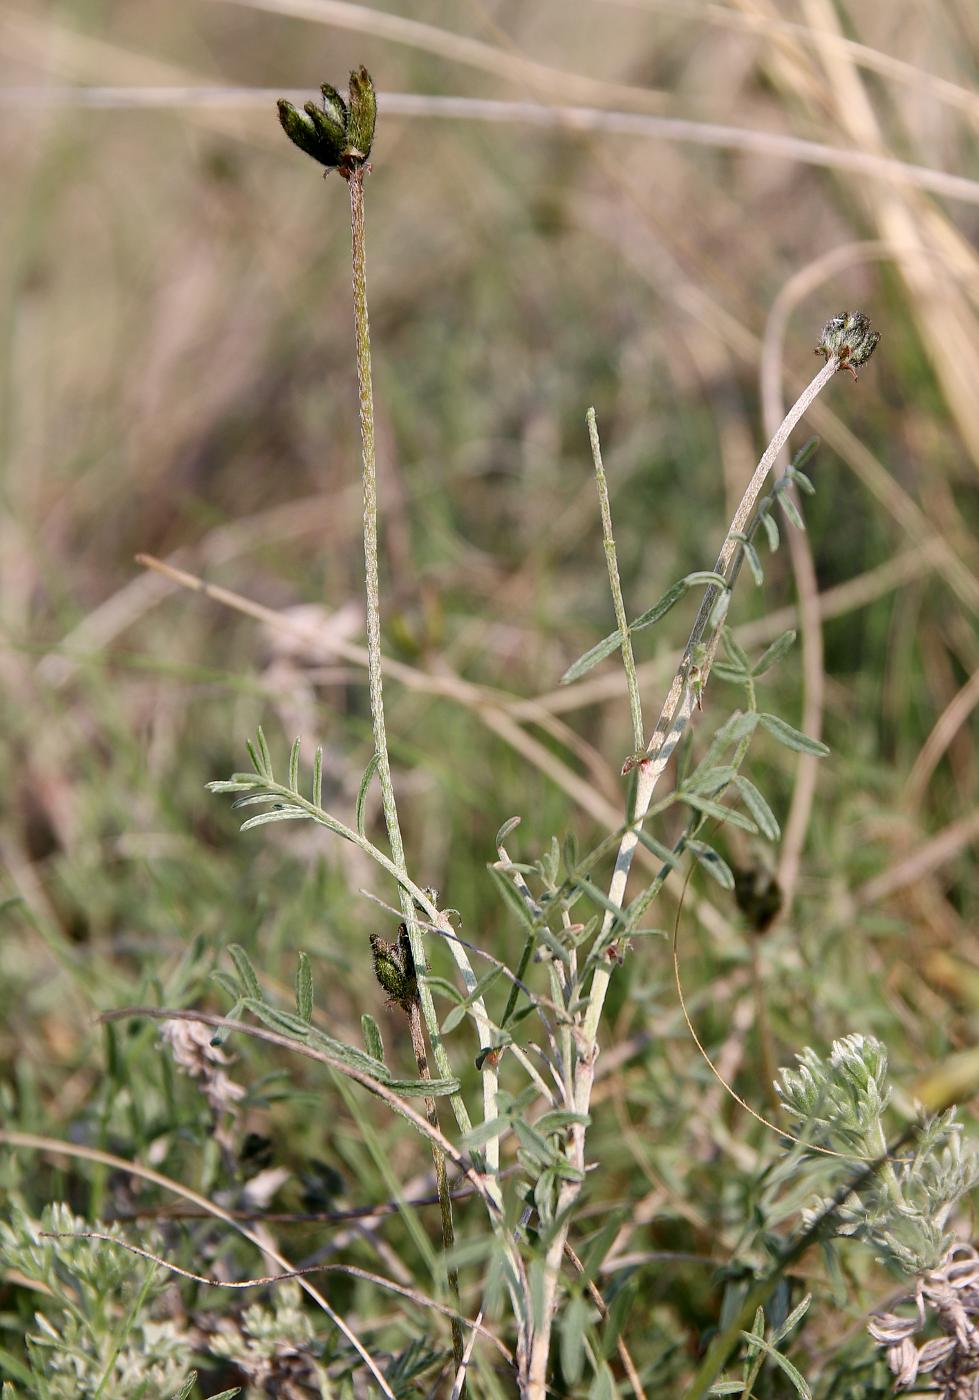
[0,1203,208,1400]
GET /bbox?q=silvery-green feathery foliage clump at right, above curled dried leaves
[775,1035,979,1274]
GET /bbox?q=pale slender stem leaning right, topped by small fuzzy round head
[525,354,839,1400]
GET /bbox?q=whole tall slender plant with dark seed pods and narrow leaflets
[187,69,974,1400]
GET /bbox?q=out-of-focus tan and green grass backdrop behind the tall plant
[0,0,979,1388]
